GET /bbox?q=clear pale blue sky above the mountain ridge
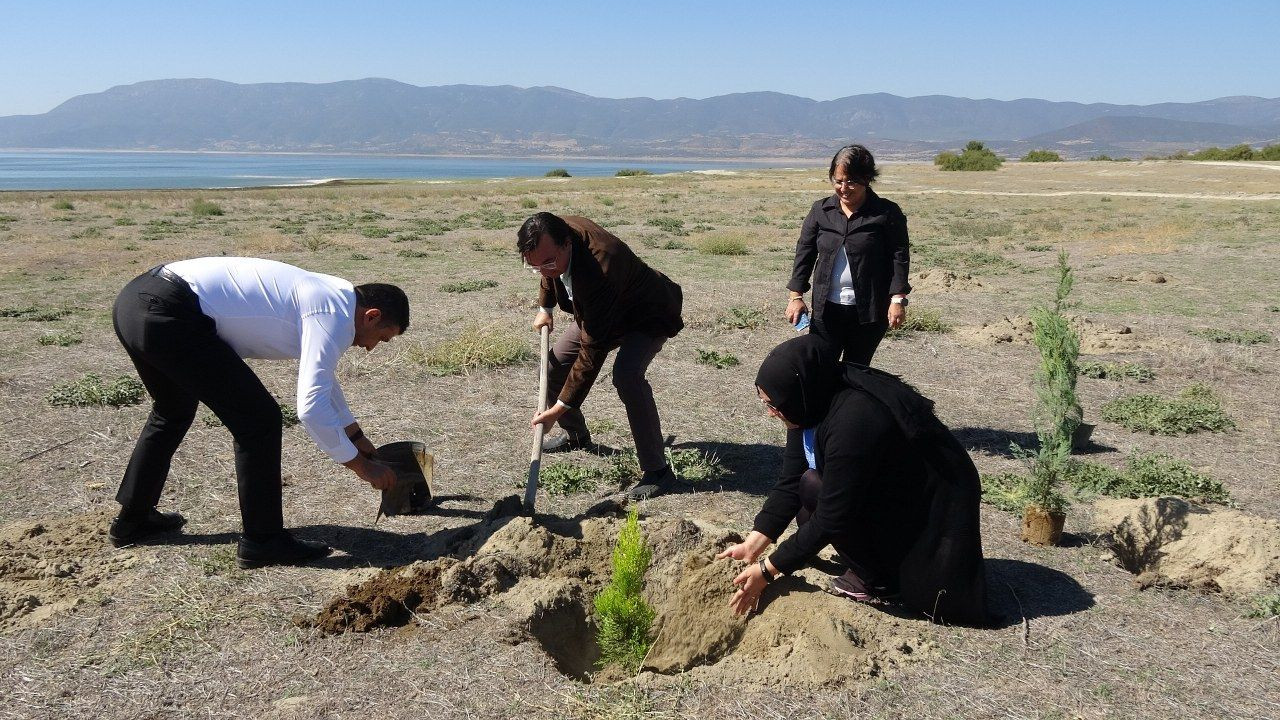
[0,0,1280,115]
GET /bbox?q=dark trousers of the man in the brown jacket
[547,323,667,473]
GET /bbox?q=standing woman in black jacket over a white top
[786,145,911,365]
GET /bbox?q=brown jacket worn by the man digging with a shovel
[538,215,685,407]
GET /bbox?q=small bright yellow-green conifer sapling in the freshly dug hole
[595,507,655,673]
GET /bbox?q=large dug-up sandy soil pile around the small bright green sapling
[308,502,932,685]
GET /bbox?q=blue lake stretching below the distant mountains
[0,151,781,190]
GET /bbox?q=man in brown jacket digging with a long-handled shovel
[516,213,685,500]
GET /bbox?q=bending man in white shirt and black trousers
[109,258,408,568]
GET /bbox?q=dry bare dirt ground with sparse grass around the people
[0,161,1280,719]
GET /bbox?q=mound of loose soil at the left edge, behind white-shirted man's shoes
[0,510,138,629]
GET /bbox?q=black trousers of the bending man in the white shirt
[113,270,284,538]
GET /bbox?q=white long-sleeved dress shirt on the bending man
[165,258,357,462]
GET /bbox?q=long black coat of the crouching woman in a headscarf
[755,365,988,625]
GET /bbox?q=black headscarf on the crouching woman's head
[755,334,844,428]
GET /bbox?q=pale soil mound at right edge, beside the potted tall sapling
[1094,497,1280,596]
